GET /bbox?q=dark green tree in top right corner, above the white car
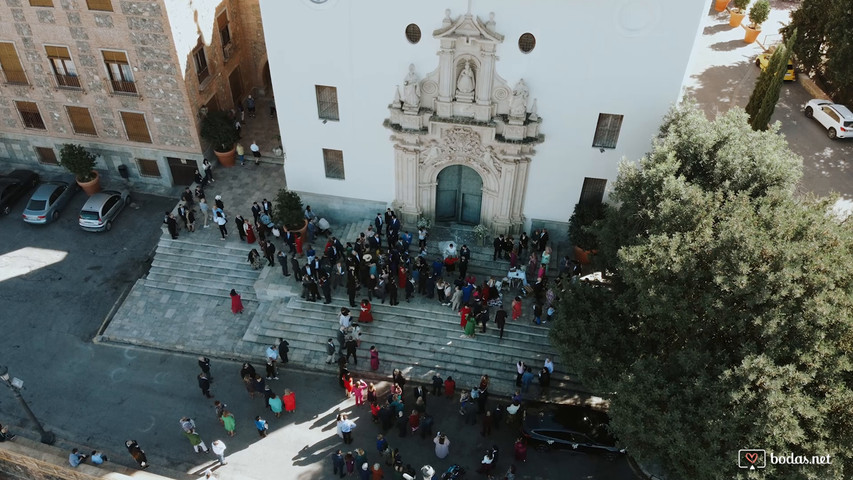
[782,0,853,103]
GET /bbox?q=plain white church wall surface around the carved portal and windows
[261,0,708,221]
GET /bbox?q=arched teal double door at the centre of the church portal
[435,165,483,225]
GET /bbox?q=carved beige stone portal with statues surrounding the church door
[385,5,543,234]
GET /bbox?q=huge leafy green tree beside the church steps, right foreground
[551,104,853,479]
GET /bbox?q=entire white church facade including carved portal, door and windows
[261,0,708,233]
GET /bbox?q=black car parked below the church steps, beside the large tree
[522,405,625,455]
